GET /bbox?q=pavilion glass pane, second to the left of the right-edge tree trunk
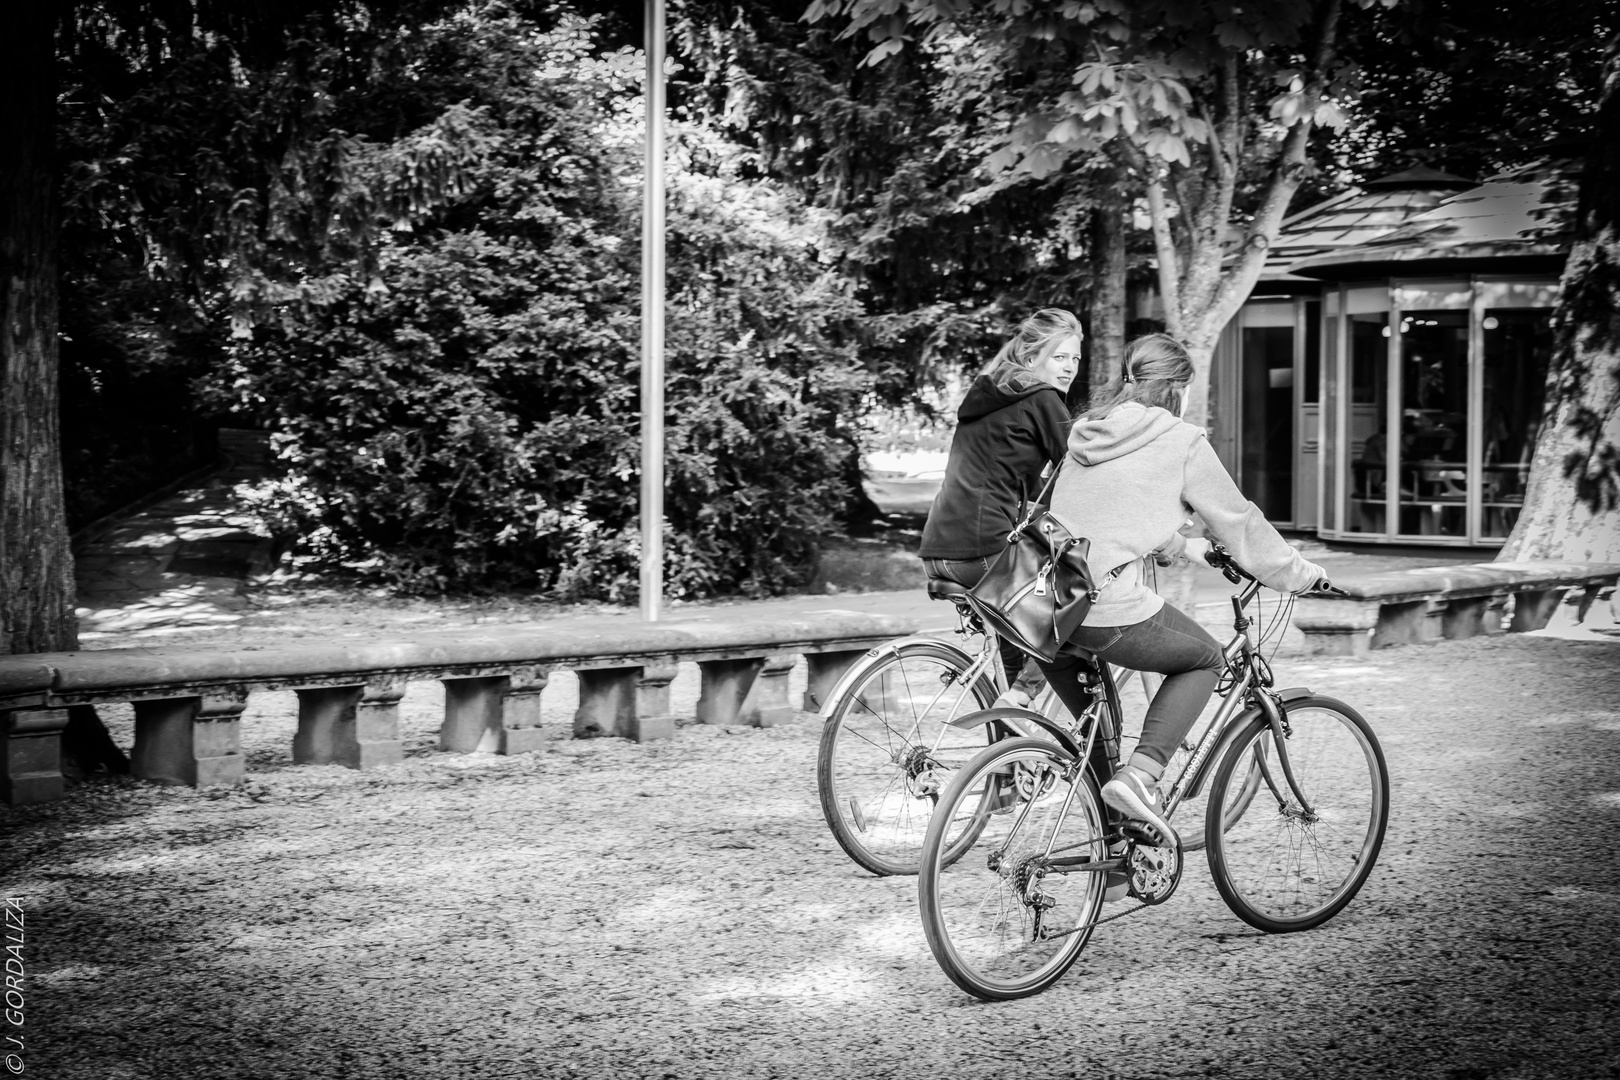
[1396,311,1468,538]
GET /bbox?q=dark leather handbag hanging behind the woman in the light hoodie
[967,473,1124,664]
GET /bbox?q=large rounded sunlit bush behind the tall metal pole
[214,13,867,601]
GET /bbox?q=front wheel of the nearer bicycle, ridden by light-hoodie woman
[1204,696,1390,934]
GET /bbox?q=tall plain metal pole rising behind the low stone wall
[642,0,664,622]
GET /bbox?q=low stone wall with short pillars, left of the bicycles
[0,614,915,803]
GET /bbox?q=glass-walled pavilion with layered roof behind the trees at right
[1198,164,1575,546]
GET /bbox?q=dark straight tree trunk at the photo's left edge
[0,3,78,653]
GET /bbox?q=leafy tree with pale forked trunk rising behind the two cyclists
[805,0,1393,433]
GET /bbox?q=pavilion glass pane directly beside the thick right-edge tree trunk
[1479,308,1552,539]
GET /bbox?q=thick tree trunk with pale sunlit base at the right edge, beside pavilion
[1497,37,1620,562]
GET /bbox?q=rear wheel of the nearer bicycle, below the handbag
[917,738,1108,1001]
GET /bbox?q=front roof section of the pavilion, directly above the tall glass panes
[1288,160,1578,279]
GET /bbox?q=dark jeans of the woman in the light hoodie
[1040,604,1226,766]
